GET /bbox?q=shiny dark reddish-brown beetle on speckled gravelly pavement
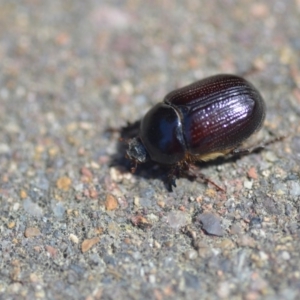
[127,74,266,187]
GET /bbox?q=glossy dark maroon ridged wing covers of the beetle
[164,75,265,157]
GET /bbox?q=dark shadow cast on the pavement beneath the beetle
[107,121,264,191]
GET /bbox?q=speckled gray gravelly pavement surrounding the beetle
[0,0,300,300]
